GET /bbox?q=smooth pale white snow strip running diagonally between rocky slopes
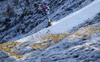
[16,0,100,42]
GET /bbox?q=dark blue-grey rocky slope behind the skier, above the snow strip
[0,0,93,43]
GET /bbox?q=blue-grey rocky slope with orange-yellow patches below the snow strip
[0,14,100,62]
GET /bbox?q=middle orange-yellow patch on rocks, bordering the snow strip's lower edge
[30,33,71,49]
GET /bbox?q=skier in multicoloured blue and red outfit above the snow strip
[34,2,51,27]
